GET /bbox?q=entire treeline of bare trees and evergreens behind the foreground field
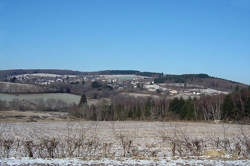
[70,89,250,121]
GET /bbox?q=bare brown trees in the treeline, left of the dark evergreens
[71,95,169,120]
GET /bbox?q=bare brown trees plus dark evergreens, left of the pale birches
[71,96,198,120]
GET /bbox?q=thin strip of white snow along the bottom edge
[0,157,250,166]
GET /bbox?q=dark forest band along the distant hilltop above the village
[0,69,247,92]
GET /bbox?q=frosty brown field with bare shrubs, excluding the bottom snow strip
[0,122,250,159]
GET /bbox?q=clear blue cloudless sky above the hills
[0,0,250,84]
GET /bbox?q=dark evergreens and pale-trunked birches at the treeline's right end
[169,88,250,121]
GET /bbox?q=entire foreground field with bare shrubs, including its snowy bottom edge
[0,121,250,165]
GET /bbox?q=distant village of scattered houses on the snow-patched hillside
[7,73,227,98]
